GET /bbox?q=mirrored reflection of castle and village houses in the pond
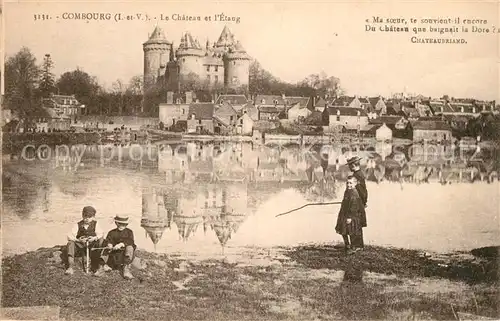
[141,142,498,247]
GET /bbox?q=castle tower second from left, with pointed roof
[176,32,204,77]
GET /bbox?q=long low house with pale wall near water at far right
[409,120,453,142]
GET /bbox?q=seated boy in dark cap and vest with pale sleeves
[66,206,104,275]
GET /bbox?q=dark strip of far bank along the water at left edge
[2,132,100,152]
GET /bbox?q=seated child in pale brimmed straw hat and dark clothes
[96,215,136,279]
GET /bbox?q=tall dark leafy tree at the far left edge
[5,47,40,126]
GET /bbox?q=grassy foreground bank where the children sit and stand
[2,245,499,320]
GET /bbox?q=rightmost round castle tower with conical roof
[224,41,250,88]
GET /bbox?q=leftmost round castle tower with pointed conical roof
[142,26,171,91]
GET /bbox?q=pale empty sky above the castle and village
[3,1,500,101]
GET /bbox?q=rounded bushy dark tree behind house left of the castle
[57,69,102,113]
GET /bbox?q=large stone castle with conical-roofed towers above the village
[143,26,251,90]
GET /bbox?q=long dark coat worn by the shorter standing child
[335,189,366,235]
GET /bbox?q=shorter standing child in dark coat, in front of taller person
[335,175,365,254]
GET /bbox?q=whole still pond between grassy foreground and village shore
[2,142,497,254]
